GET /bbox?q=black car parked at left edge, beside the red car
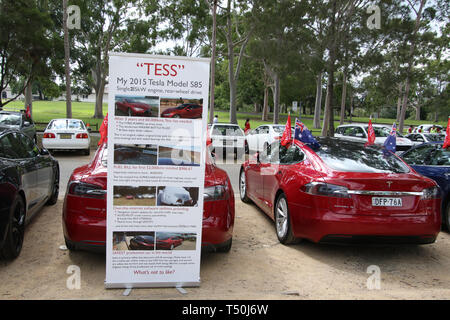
[0,129,59,259]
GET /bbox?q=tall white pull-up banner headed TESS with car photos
[105,53,210,288]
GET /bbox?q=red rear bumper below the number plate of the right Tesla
[289,204,441,243]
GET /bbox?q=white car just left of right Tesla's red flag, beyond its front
[245,124,294,152]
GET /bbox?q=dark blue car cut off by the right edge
[401,142,450,231]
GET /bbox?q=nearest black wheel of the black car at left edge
[0,195,25,260]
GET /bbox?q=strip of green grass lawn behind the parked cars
[4,101,447,136]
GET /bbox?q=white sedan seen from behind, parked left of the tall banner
[42,119,91,155]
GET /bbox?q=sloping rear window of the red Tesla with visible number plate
[316,141,409,173]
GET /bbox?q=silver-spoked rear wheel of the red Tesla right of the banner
[274,193,299,244]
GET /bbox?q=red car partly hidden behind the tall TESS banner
[62,144,235,252]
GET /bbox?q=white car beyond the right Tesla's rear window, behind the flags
[334,123,413,151]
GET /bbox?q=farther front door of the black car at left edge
[16,133,53,202]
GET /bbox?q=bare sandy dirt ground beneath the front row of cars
[0,198,450,300]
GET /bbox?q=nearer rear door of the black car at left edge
[1,133,38,212]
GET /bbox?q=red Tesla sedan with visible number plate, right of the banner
[239,138,441,244]
